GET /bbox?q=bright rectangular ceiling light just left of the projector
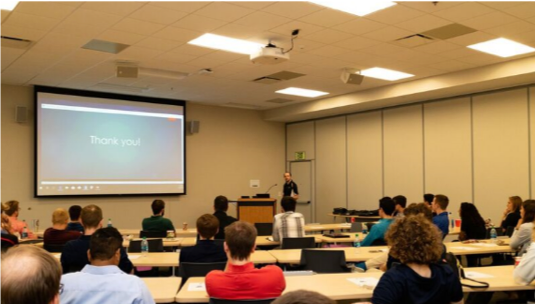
[188,34,264,55]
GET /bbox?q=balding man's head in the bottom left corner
[0,246,61,304]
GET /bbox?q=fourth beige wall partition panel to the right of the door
[426,97,473,218]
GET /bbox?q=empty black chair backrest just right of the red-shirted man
[300,249,350,273]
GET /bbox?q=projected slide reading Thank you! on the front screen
[36,91,185,196]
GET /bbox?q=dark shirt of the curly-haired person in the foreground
[372,264,463,304]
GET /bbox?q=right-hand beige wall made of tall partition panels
[287,84,535,224]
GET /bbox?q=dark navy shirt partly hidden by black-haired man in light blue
[61,235,134,273]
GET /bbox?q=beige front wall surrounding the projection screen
[0,85,285,229]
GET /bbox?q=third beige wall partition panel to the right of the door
[383,104,424,202]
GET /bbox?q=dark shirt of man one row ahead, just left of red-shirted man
[180,240,227,263]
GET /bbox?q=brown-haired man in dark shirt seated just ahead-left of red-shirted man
[180,214,227,263]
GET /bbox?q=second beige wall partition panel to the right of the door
[347,111,383,210]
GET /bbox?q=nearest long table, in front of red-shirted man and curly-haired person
[175,266,535,303]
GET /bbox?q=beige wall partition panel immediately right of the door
[316,116,347,223]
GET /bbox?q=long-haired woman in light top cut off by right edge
[509,200,535,256]
